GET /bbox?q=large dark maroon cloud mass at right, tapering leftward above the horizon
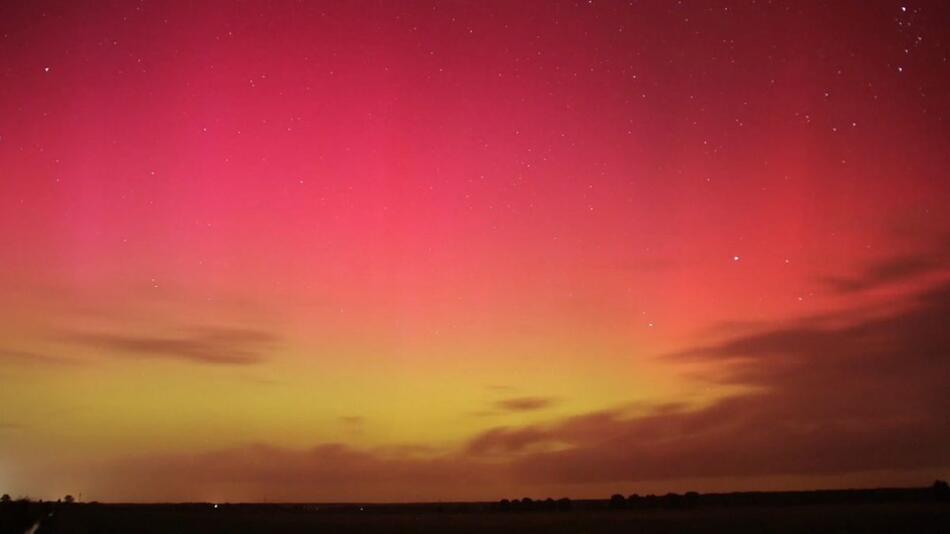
[494,284,950,483]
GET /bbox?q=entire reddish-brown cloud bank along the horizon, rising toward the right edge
[44,278,950,501]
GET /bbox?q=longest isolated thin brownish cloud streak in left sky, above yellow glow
[60,328,277,365]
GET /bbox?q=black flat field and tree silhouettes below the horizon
[2,494,950,534]
